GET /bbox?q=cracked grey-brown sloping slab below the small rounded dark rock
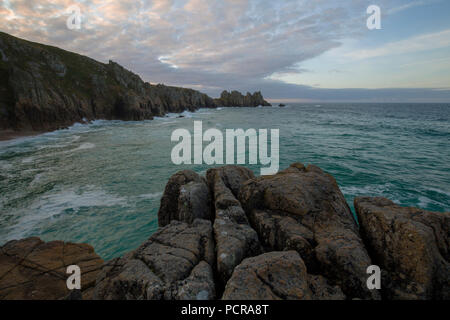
[94,219,215,300]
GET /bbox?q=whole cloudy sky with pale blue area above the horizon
[0,0,450,102]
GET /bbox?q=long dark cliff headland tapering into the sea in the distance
[0,32,270,137]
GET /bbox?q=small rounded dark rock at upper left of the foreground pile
[158,170,212,227]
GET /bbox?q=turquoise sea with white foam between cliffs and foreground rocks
[0,104,450,259]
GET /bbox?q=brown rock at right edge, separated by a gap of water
[355,198,450,300]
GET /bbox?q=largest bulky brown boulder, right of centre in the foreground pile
[239,163,380,299]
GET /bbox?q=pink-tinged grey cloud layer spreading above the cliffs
[0,0,450,101]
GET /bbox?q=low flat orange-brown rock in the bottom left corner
[0,238,103,300]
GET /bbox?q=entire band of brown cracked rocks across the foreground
[0,163,450,300]
